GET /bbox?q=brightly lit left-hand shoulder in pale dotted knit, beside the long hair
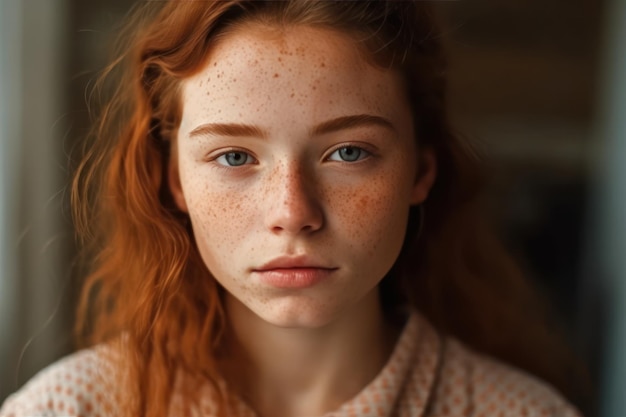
[0,346,118,417]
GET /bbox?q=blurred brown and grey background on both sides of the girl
[0,0,626,417]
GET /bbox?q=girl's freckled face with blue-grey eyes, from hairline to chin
[169,26,434,327]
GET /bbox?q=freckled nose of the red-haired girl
[265,163,324,235]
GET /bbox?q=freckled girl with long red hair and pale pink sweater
[0,0,577,417]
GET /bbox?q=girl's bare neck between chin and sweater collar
[221,291,397,417]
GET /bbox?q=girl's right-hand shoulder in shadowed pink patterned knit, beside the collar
[426,339,580,417]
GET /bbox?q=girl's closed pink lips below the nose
[252,256,338,289]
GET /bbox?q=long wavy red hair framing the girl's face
[72,0,584,416]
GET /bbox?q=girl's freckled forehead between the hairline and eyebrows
[181,24,407,133]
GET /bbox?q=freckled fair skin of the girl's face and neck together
[169,25,435,416]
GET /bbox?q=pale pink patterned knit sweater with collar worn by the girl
[0,313,579,417]
